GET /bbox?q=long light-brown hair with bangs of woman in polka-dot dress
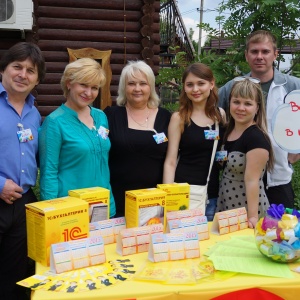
[224,78,274,171]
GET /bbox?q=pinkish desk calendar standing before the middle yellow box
[116,223,163,256]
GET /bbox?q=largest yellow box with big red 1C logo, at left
[25,197,89,266]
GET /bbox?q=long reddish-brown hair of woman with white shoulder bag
[179,63,222,132]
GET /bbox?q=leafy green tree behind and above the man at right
[218,0,300,71]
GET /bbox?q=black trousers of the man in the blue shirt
[0,189,37,300]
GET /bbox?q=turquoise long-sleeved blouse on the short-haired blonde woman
[39,104,116,217]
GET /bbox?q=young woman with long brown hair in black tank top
[163,63,225,221]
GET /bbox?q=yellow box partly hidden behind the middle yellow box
[157,183,190,212]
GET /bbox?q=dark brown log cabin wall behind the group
[0,0,160,117]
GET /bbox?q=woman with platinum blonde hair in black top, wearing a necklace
[104,61,171,216]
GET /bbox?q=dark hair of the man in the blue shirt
[0,42,46,82]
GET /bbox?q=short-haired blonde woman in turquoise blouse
[39,58,116,217]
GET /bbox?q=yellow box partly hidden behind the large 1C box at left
[68,187,110,222]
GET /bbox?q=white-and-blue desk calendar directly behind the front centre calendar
[167,216,209,241]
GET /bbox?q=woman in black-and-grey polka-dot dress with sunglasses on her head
[217,77,274,228]
